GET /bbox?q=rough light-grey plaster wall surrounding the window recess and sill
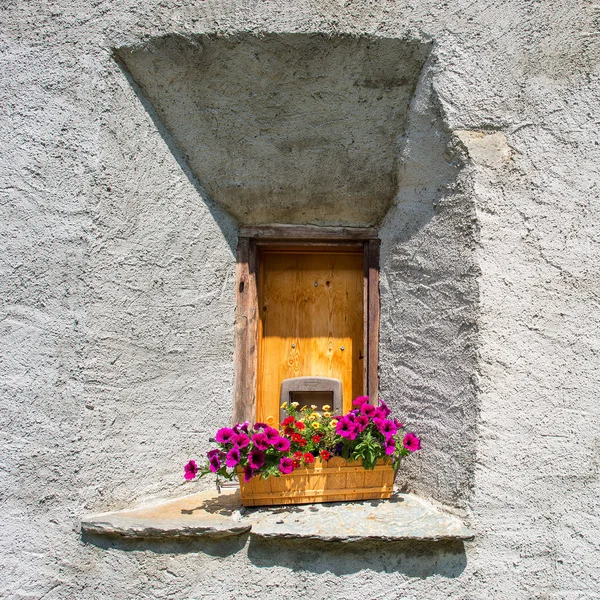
[0,0,600,600]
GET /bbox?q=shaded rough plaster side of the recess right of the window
[379,58,479,508]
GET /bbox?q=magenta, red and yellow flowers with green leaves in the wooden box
[184,396,421,485]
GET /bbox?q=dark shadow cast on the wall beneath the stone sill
[82,534,467,579]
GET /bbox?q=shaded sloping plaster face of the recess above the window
[117,34,431,225]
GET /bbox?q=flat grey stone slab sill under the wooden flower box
[81,489,473,542]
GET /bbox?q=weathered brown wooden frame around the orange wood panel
[233,225,380,423]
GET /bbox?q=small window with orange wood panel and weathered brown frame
[233,225,379,422]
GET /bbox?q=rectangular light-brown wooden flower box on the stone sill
[237,456,395,506]
